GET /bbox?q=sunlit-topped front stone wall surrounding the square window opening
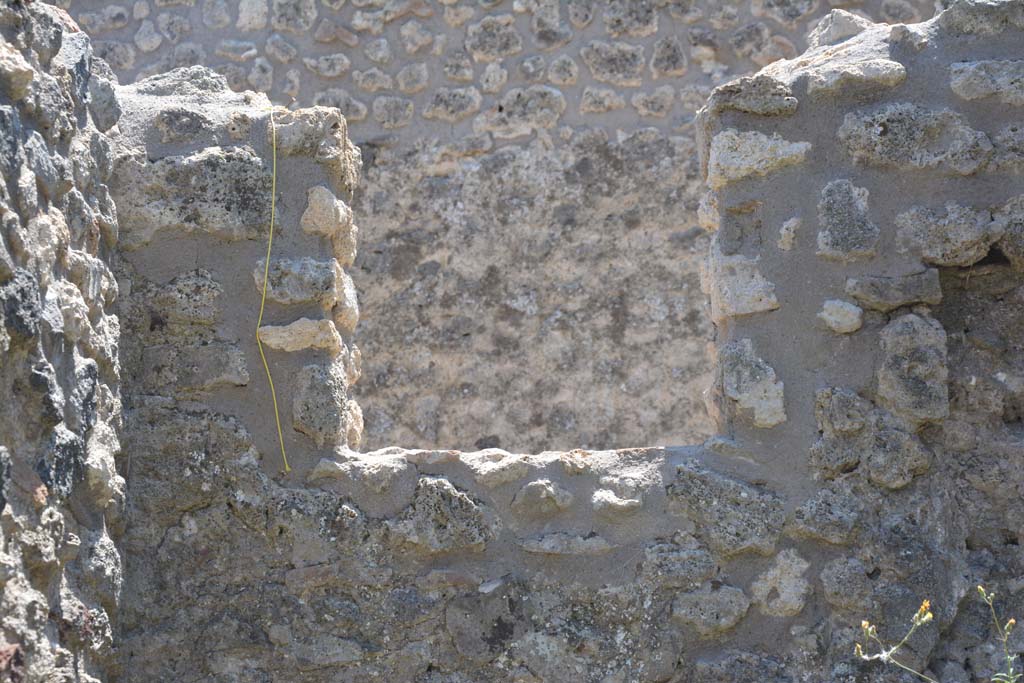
[96,0,1024,683]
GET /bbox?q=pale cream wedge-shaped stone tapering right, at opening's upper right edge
[708,128,811,189]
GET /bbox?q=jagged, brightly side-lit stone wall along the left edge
[0,2,125,683]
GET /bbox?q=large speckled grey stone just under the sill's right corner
[668,462,785,557]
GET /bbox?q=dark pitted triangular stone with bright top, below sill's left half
[386,476,498,553]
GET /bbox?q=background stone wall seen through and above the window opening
[59,0,934,452]
